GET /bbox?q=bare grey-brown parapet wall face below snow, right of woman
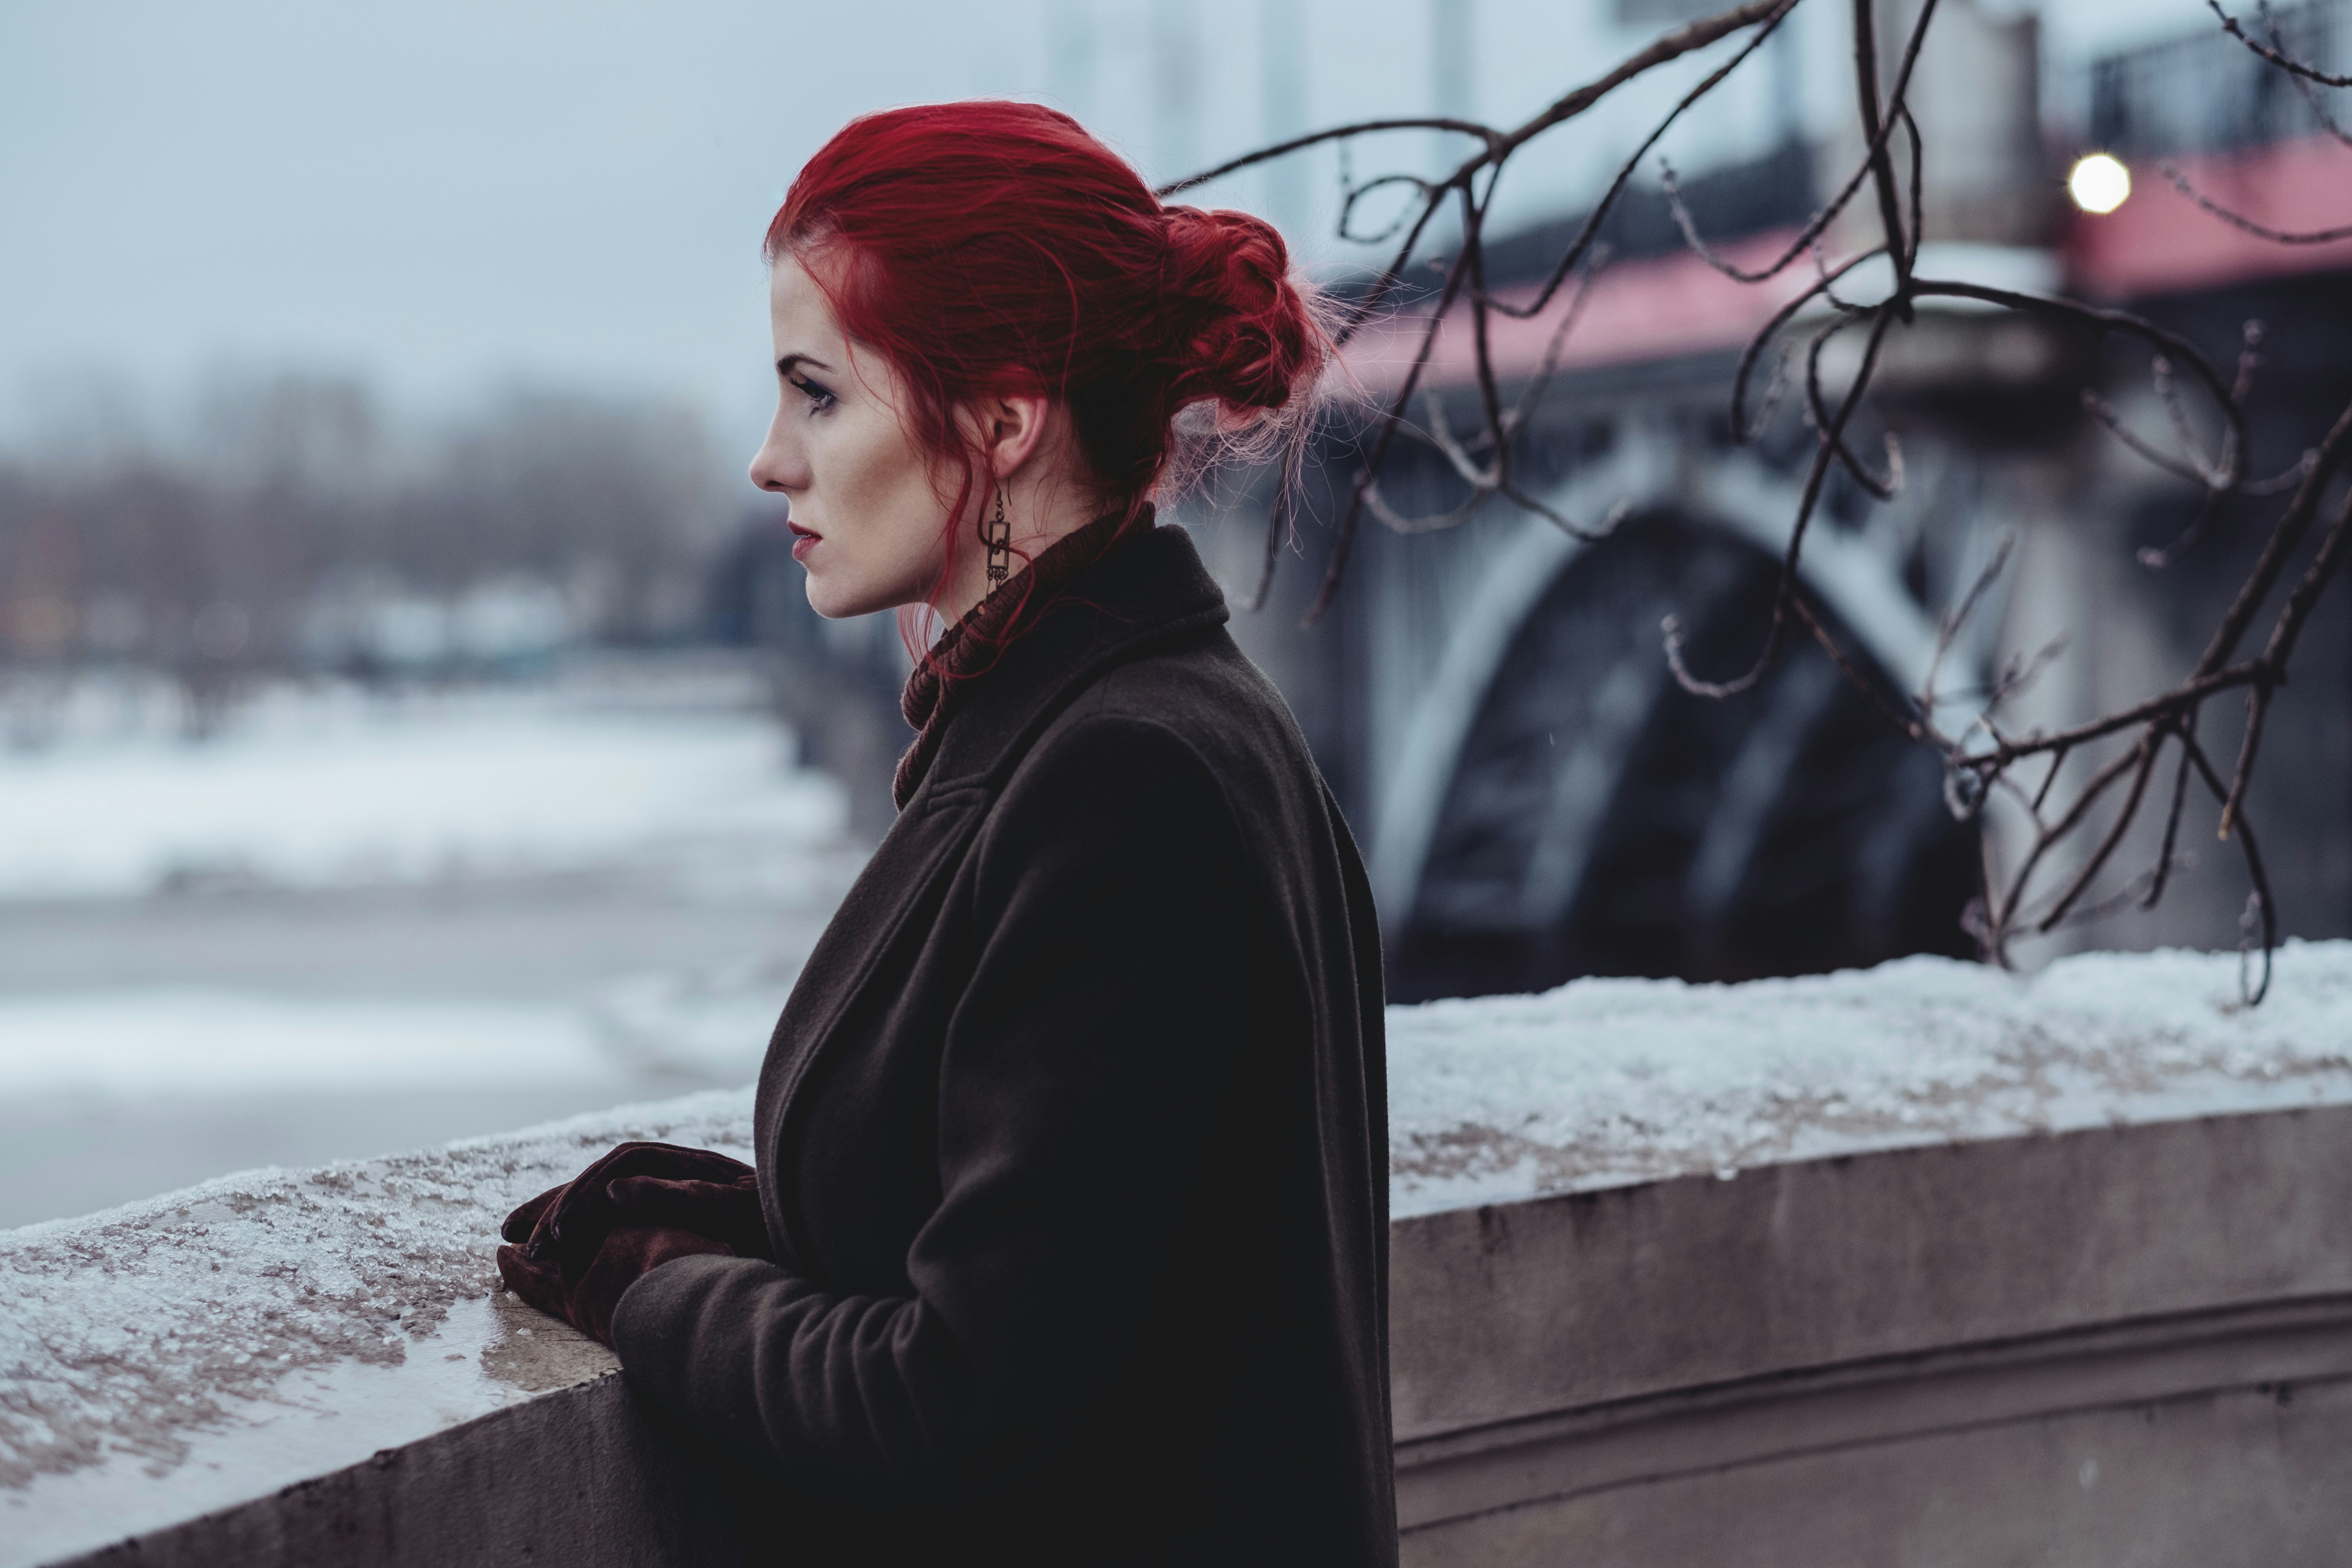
[1392,1107,2352,1568]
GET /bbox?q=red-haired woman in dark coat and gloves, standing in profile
[499,103,1397,1566]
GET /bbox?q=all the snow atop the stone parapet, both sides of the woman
[0,943,2352,1568]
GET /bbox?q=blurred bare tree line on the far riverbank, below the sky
[0,374,734,729]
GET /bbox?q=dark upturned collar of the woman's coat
[908,526,1228,809]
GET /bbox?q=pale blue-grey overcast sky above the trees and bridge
[0,0,2204,475]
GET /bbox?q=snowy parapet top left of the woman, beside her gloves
[0,1089,750,1568]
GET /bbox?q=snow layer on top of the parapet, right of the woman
[1388,943,2352,1218]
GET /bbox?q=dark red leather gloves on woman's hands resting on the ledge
[499,1143,771,1345]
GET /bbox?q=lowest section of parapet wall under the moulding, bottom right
[1404,1352,2352,1568]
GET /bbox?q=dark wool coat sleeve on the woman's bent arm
[614,717,1268,1507]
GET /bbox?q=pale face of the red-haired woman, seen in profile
[750,254,948,618]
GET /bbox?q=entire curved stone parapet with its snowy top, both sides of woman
[14,945,2352,1568]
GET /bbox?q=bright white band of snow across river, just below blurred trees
[0,686,844,898]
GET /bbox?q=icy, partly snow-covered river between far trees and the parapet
[0,677,861,1227]
